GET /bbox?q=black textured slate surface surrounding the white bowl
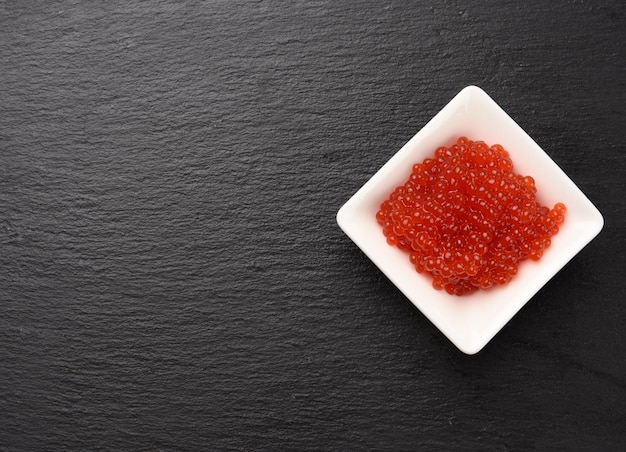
[0,0,626,451]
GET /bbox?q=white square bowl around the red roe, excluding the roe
[337,86,604,354]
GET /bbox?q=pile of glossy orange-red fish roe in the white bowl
[376,137,565,295]
